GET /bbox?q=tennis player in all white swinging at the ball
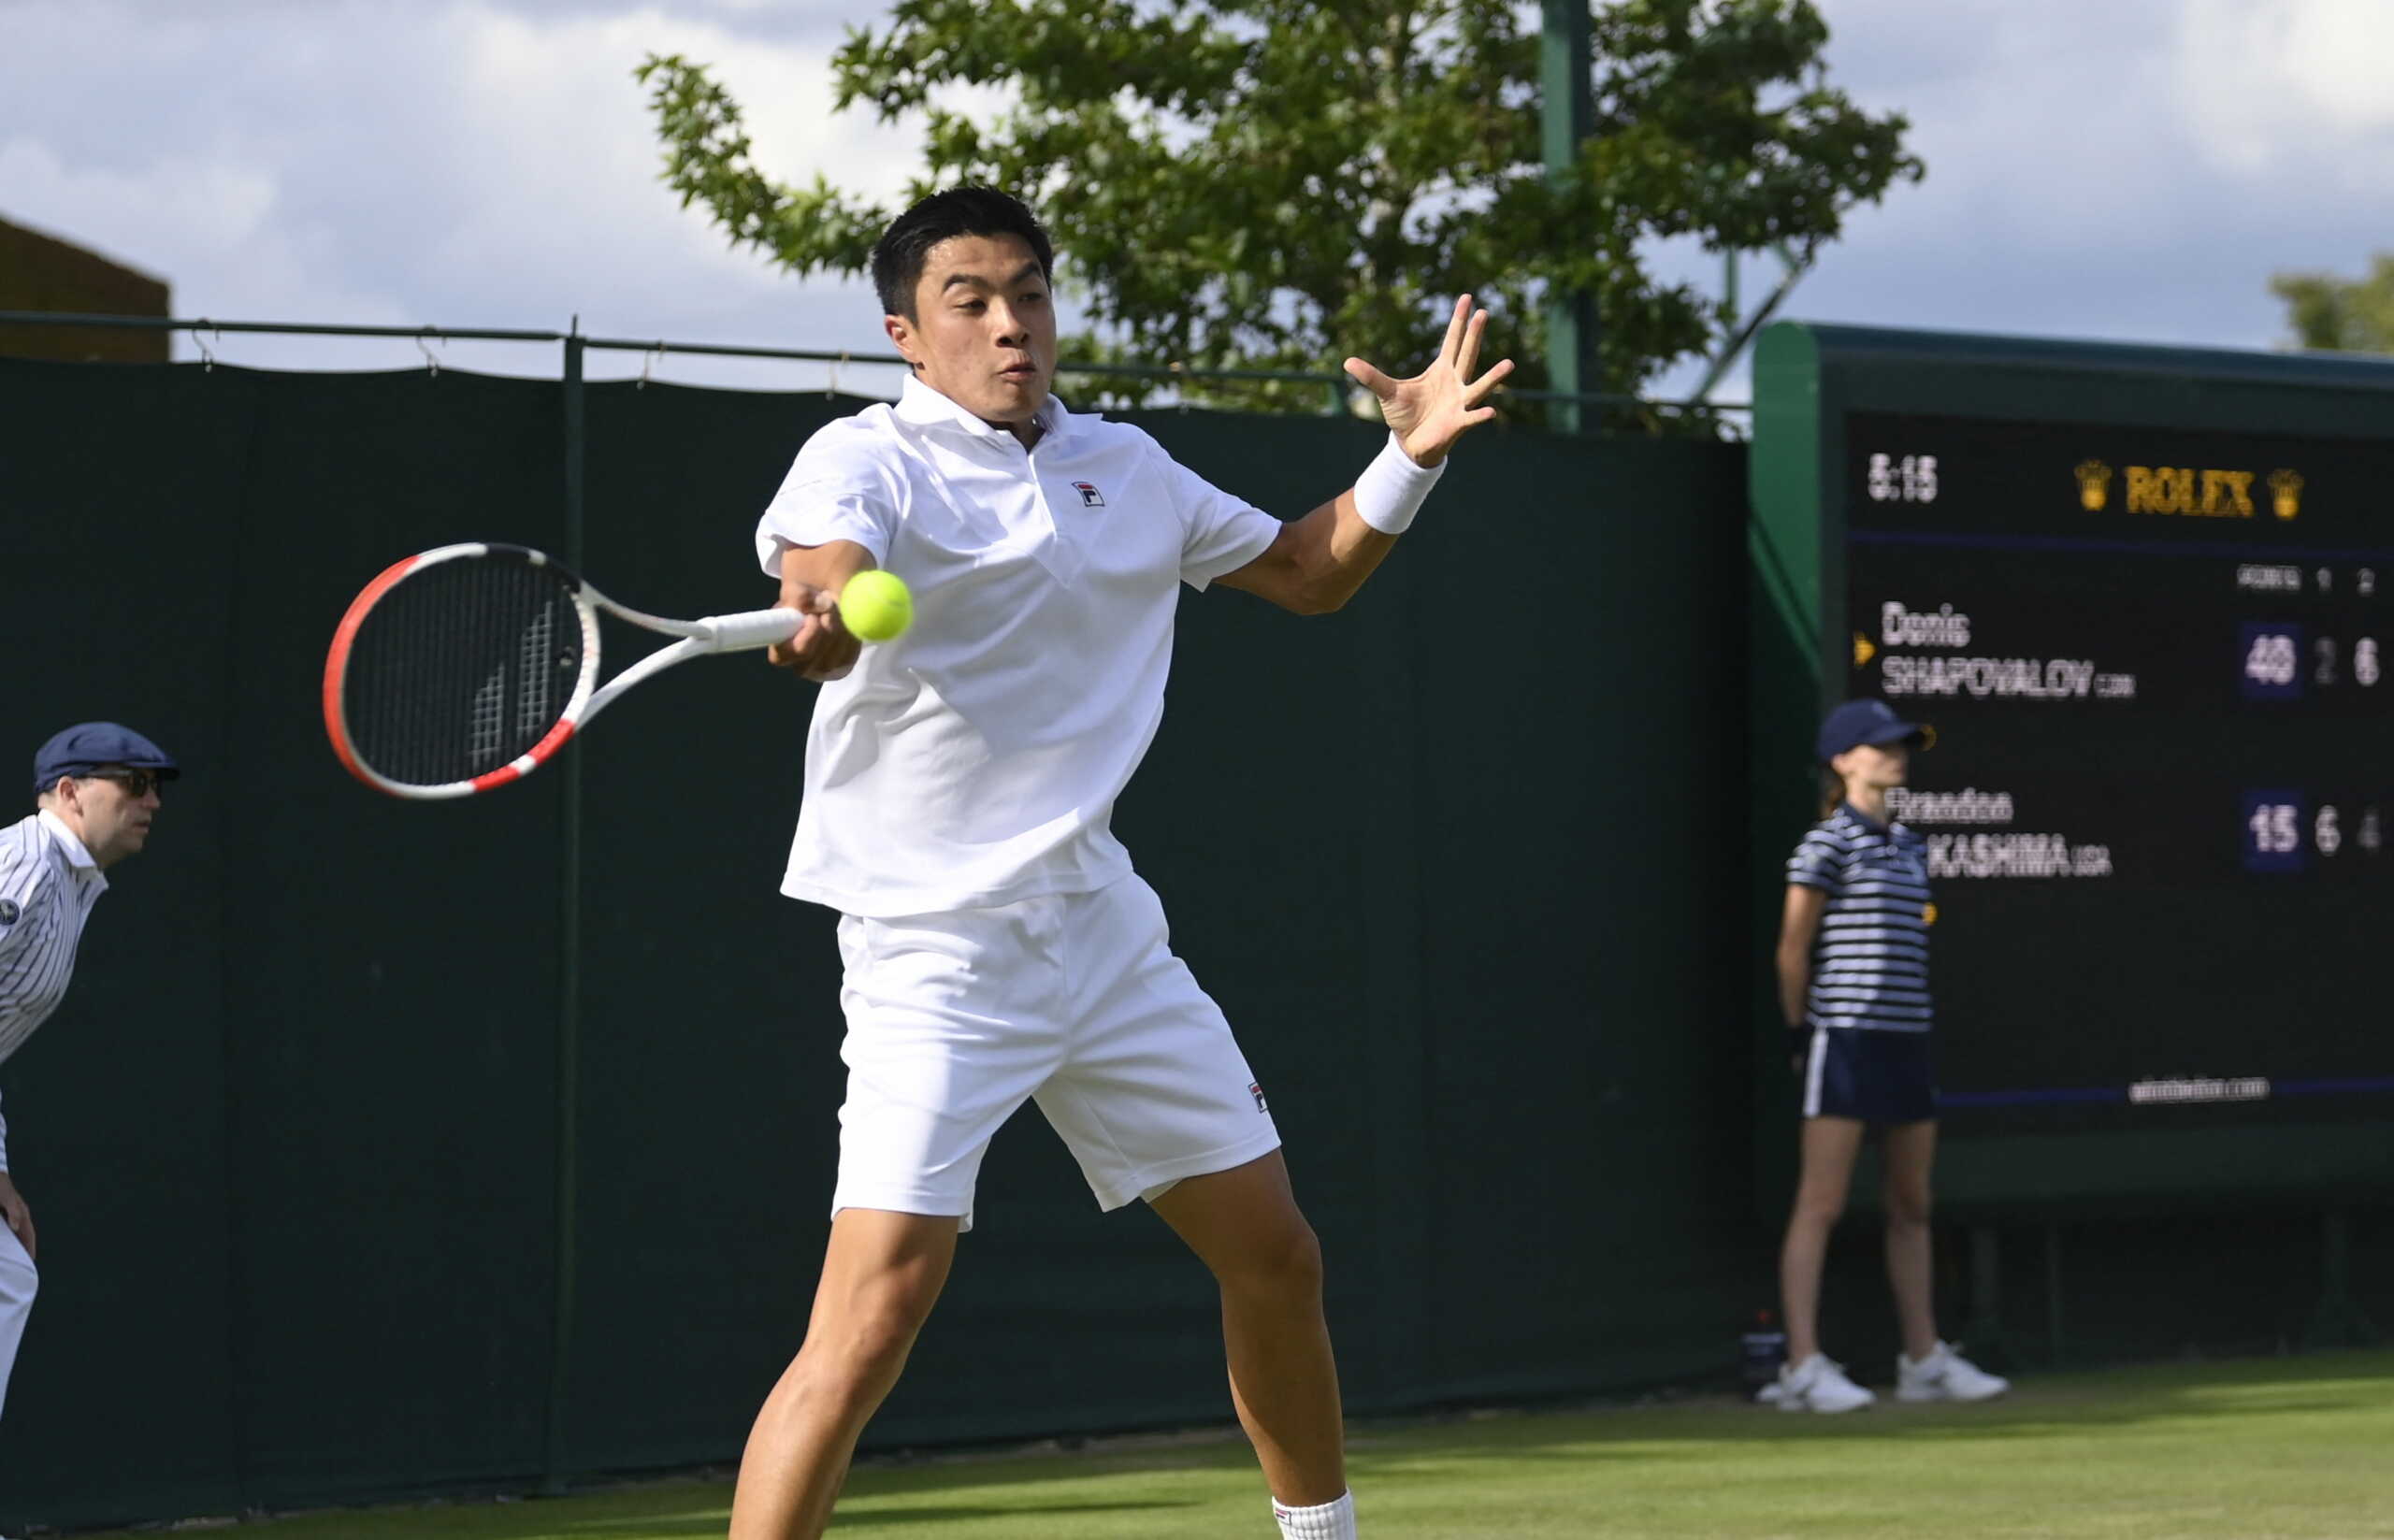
[732,187,1510,1540]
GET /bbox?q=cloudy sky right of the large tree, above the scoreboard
[1733,0,2394,359]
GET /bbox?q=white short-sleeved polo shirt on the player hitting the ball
[757,379,1281,920]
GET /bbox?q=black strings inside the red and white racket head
[342,551,584,785]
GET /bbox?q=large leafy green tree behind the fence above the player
[637,0,1923,428]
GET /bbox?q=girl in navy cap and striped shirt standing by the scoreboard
[1779,699,2011,1413]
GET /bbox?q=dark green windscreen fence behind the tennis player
[0,362,1767,1526]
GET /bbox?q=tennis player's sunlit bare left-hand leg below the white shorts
[730,1210,955,1540]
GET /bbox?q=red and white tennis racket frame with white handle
[324,541,802,802]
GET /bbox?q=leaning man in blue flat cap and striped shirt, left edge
[0,721,180,1403]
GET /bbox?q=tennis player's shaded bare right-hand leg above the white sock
[1154,1149,1348,1506]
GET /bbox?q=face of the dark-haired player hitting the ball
[881,235,1056,424]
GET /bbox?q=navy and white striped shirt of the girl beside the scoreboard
[1788,805,1929,1032]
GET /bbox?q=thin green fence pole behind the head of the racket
[543,316,586,1494]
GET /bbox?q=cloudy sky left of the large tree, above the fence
[0,0,912,379]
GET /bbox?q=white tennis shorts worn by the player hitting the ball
[830,876,1281,1229]
